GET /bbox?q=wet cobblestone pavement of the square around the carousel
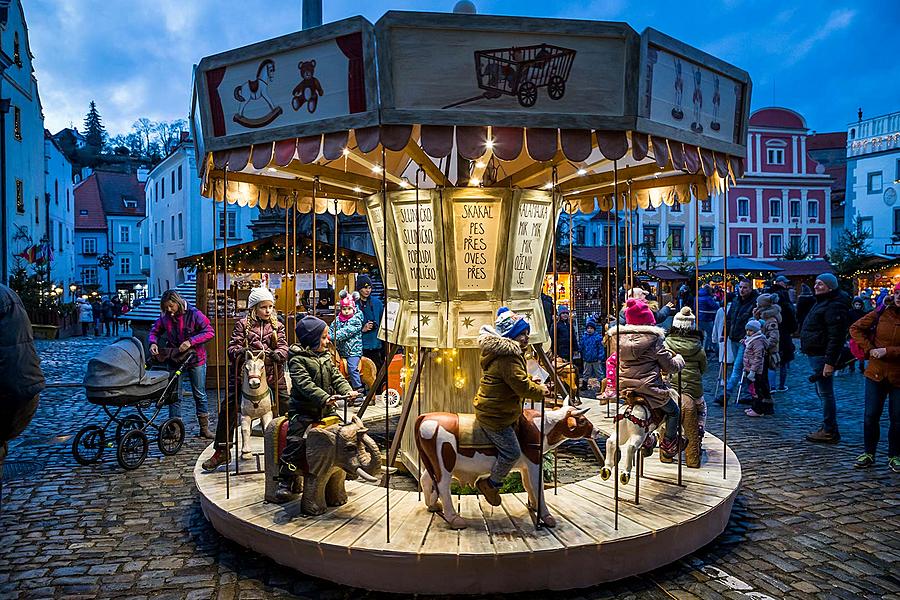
[0,338,900,600]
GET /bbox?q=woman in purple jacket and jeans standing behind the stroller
[149,290,215,440]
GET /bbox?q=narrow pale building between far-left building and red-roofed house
[44,131,78,292]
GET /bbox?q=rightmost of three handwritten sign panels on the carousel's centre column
[510,202,551,292]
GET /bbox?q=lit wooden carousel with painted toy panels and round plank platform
[192,12,750,593]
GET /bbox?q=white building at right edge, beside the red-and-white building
[845,112,900,255]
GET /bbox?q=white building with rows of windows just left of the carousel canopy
[141,134,259,297]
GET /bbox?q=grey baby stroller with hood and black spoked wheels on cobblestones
[72,337,194,470]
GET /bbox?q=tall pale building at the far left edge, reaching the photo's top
[0,0,46,282]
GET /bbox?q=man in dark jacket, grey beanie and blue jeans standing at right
[800,273,850,444]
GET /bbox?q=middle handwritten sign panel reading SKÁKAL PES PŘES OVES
[453,201,500,292]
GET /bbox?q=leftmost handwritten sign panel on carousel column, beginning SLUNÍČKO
[392,203,439,292]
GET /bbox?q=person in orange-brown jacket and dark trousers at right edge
[850,284,900,473]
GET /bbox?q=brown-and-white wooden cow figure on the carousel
[415,403,595,529]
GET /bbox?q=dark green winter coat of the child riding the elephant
[288,344,353,421]
